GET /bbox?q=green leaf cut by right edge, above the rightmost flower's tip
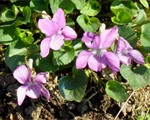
[140,23,150,51]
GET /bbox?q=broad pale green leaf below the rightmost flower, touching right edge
[120,64,150,90]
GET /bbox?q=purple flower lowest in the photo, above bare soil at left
[13,65,50,105]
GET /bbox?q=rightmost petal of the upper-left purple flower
[62,26,77,40]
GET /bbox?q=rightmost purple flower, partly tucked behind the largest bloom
[116,37,145,66]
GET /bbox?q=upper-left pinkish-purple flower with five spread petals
[38,8,77,58]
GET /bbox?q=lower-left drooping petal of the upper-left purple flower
[40,37,51,58]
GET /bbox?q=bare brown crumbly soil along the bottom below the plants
[0,61,150,120]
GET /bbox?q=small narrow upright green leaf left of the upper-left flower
[23,6,31,23]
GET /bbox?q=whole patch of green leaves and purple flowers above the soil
[0,0,150,108]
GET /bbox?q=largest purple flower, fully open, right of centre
[76,26,120,74]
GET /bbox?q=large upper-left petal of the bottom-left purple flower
[13,65,31,84]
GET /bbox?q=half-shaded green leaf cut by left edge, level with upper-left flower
[0,26,20,45]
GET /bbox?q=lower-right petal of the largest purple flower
[104,52,120,74]
